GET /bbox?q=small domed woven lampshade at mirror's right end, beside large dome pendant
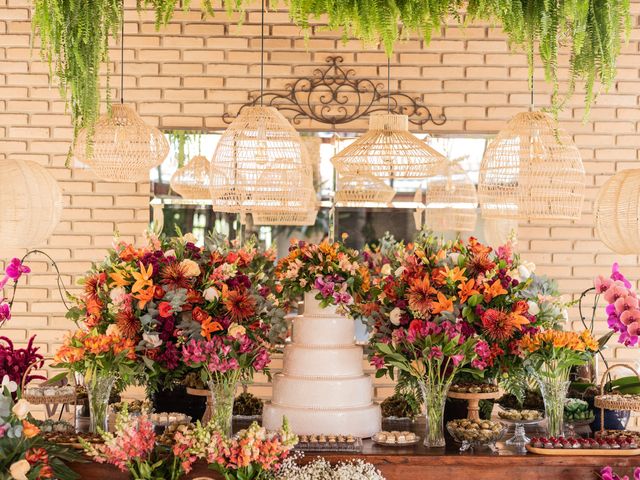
[425,159,478,232]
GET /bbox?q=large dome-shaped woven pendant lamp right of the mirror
[478,111,585,220]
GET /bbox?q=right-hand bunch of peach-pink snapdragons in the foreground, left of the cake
[174,419,298,480]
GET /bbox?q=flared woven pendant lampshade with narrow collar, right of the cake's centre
[331,113,444,180]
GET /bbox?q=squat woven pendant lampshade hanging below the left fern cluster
[74,104,169,182]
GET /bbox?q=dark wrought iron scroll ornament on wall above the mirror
[222,56,447,128]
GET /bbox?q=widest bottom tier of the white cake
[262,403,382,438]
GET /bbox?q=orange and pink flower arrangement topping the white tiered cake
[276,237,370,310]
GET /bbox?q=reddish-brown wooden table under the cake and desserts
[71,441,640,480]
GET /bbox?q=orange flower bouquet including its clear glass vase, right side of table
[519,330,598,437]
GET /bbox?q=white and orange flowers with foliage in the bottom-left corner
[0,375,78,480]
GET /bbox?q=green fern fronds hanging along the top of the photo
[33,0,631,151]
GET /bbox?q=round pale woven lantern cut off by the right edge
[594,169,640,254]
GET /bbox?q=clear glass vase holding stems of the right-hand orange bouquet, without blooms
[534,366,570,437]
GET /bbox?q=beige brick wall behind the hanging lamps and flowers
[0,0,640,414]
